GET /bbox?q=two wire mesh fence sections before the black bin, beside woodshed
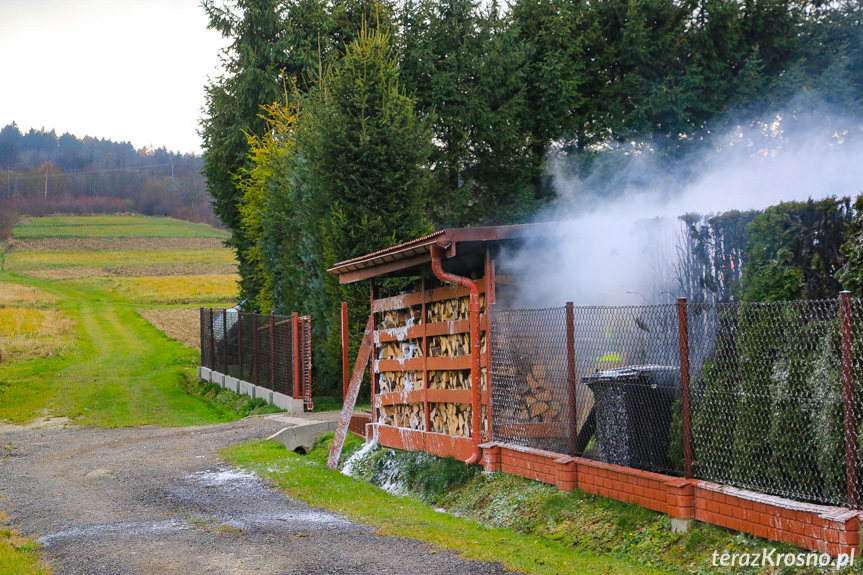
[491,305,680,472]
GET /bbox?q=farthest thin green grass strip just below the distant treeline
[15,216,230,240]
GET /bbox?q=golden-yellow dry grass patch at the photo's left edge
[0,308,74,362]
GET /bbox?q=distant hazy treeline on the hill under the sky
[0,122,217,224]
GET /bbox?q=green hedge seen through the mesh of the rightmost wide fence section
[693,304,845,501]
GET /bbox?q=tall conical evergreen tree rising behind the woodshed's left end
[295,24,432,392]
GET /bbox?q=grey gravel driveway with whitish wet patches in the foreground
[0,418,506,575]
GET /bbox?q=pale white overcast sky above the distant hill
[0,0,228,153]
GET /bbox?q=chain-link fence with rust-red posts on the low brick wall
[491,299,863,507]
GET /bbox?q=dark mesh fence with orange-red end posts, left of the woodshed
[201,308,312,409]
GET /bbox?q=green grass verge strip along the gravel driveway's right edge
[221,438,665,575]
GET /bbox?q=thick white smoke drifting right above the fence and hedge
[498,104,863,308]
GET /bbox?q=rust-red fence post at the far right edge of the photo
[839,291,860,509]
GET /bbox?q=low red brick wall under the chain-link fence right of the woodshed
[482,443,860,555]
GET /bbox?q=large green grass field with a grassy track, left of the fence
[0,216,238,427]
